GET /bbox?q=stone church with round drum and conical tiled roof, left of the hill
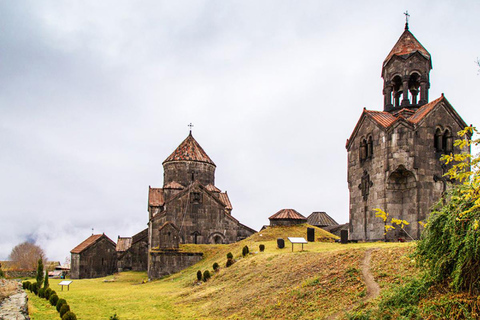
[148,132,255,279]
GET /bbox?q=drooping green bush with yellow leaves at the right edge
[416,127,480,294]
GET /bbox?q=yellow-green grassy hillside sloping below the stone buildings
[26,225,416,320]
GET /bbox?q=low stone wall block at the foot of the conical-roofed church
[148,250,203,279]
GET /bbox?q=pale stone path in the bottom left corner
[0,279,30,320]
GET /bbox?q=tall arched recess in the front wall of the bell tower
[386,165,418,239]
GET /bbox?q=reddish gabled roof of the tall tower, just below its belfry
[346,93,467,149]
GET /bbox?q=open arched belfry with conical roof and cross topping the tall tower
[382,17,432,113]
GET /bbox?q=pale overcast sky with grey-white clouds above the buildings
[0,0,480,262]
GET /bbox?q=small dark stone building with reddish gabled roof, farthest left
[70,234,117,279]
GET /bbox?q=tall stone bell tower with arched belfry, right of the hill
[346,24,468,240]
